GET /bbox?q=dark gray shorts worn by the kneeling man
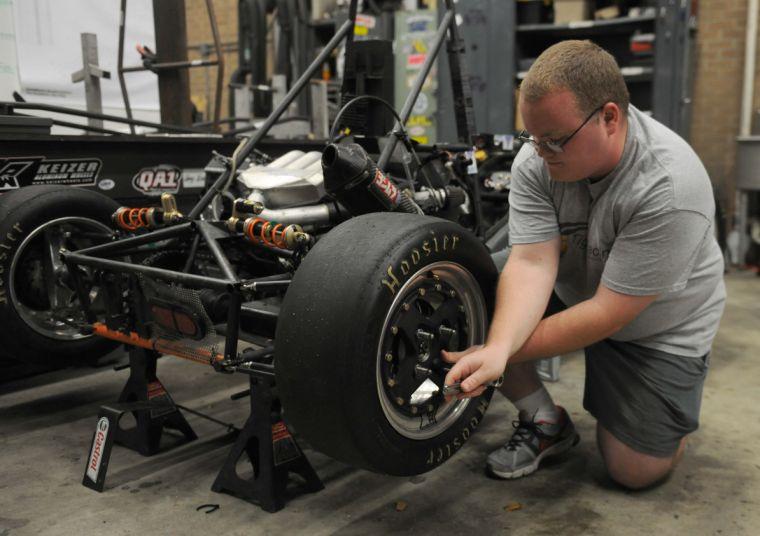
[583,339,710,457]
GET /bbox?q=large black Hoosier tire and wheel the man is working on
[275,213,498,475]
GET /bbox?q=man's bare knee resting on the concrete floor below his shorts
[597,424,685,490]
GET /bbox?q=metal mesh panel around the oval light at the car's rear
[138,274,225,364]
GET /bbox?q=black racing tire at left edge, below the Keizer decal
[0,185,119,366]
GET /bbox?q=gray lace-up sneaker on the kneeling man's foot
[486,406,581,478]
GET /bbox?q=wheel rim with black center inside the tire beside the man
[376,262,487,440]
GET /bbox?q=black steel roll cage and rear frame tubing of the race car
[61,0,477,368]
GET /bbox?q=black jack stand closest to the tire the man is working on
[211,376,324,512]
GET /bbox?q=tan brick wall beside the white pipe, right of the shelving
[691,0,760,220]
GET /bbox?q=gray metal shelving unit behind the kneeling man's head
[438,0,696,139]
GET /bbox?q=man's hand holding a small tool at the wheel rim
[441,345,509,398]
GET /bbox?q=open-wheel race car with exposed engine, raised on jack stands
[0,0,504,475]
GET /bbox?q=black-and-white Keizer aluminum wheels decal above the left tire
[0,156,103,193]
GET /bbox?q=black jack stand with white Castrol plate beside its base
[82,347,198,492]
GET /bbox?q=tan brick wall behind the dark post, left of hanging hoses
[185,0,238,120]
